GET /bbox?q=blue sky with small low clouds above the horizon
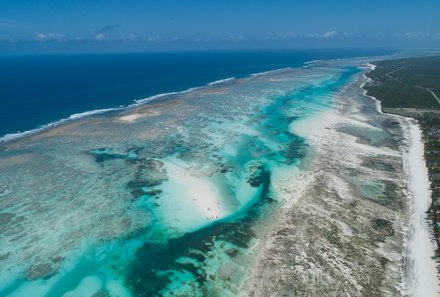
[0,0,440,52]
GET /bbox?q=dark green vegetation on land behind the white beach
[365,56,440,257]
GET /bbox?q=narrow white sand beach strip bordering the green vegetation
[360,63,440,296]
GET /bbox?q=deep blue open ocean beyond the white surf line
[0,49,393,137]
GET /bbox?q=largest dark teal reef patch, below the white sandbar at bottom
[126,219,255,296]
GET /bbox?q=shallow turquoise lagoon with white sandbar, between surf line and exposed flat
[0,63,359,296]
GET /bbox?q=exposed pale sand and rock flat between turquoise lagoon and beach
[242,69,410,297]
